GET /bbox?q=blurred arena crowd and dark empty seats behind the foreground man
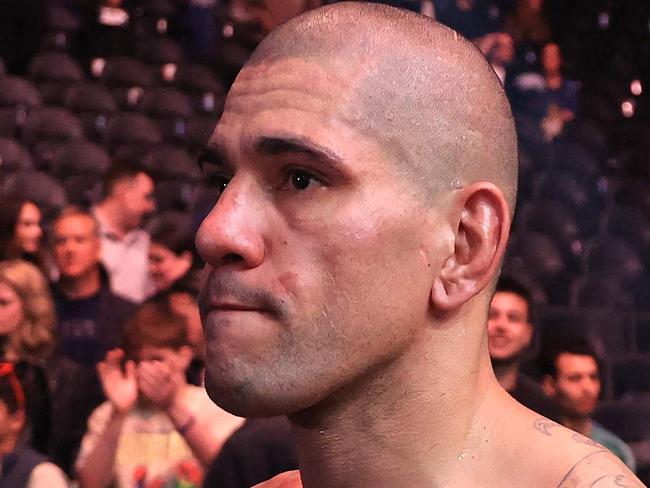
[0,0,650,487]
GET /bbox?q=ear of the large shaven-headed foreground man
[431,182,510,312]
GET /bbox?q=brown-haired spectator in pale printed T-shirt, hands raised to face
[76,300,243,488]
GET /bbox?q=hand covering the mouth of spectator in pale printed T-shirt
[136,360,183,410]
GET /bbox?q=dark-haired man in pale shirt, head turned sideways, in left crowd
[94,162,156,303]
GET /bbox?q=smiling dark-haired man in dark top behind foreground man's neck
[488,276,560,420]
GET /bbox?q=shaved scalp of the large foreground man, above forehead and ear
[238,2,517,210]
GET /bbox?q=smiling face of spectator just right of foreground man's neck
[488,291,533,363]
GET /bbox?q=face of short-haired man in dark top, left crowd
[52,215,100,279]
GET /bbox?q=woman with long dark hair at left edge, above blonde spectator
[0,200,43,266]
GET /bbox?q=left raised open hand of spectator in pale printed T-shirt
[97,349,138,413]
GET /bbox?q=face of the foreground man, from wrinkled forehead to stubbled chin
[197,60,442,416]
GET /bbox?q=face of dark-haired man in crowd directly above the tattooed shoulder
[552,353,600,417]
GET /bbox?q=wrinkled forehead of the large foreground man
[209,58,380,159]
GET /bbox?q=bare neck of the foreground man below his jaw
[289,332,507,488]
